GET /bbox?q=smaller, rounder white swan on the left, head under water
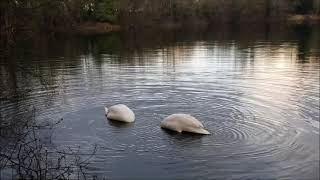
[104,104,135,122]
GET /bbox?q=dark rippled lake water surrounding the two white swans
[0,27,320,179]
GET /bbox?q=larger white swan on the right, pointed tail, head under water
[160,114,210,134]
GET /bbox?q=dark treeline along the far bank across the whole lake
[0,0,320,48]
